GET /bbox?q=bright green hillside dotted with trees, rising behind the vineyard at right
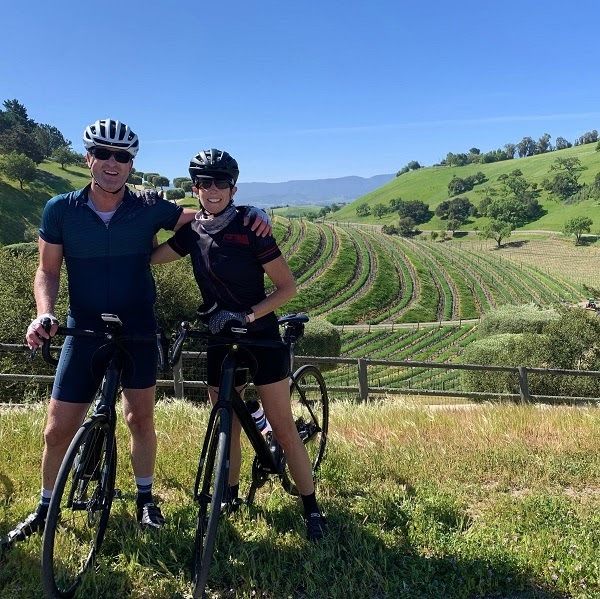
[328,143,600,231]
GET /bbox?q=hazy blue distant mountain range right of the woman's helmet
[235,174,395,208]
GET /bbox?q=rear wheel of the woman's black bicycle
[281,364,329,495]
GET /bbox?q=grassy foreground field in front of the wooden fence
[0,400,600,599]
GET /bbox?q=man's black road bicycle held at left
[36,314,164,597]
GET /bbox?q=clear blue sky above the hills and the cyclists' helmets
[0,0,600,182]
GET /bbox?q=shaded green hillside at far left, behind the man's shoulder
[0,161,90,245]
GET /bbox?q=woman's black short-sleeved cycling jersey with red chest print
[168,211,281,331]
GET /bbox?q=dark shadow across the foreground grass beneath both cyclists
[0,494,566,599]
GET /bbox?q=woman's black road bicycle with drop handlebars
[170,314,329,598]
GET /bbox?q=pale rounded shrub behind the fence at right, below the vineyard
[478,304,559,337]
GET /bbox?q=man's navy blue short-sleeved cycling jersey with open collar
[40,185,182,328]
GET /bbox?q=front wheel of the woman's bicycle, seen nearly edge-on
[193,409,231,597]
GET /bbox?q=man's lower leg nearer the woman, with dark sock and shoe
[123,385,164,528]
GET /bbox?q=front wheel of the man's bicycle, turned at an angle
[42,416,117,597]
